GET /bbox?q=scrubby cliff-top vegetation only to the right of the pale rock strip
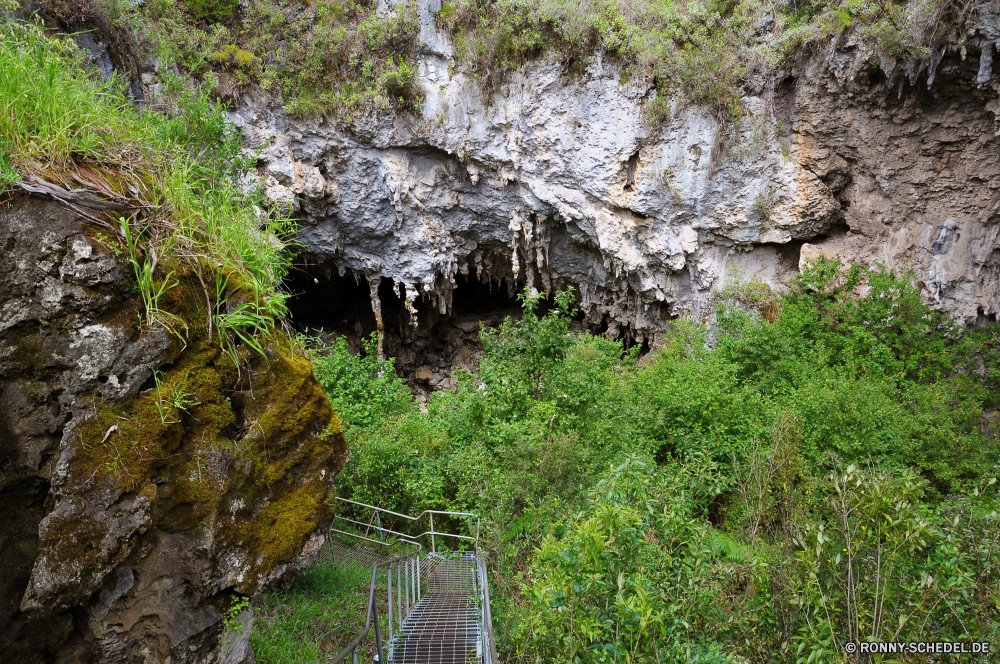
[438,0,983,132]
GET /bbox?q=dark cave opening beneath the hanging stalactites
[286,261,521,398]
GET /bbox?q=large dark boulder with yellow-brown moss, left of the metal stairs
[0,197,346,664]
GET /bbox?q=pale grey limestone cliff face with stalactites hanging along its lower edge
[233,3,1000,360]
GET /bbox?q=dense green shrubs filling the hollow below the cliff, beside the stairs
[316,259,1000,662]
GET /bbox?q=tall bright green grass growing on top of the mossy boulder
[0,16,294,365]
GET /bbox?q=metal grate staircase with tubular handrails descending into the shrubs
[331,498,498,664]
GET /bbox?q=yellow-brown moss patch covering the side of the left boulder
[57,264,346,593]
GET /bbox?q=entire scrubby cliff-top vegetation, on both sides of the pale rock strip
[35,0,986,123]
